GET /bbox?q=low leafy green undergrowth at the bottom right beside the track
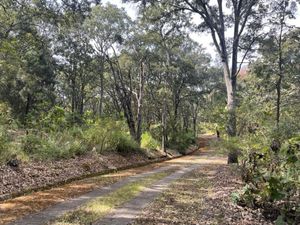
[212,130,300,224]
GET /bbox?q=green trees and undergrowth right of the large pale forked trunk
[211,59,300,224]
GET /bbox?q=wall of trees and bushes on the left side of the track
[0,0,204,166]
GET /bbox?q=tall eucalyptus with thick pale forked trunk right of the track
[126,0,265,140]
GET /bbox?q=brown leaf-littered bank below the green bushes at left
[0,152,159,197]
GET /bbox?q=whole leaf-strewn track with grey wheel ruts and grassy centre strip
[0,136,272,225]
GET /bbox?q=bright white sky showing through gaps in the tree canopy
[102,0,300,58]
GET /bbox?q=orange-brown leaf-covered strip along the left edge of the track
[0,158,176,224]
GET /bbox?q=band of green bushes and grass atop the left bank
[0,107,140,163]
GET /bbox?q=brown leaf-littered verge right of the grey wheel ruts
[133,149,272,225]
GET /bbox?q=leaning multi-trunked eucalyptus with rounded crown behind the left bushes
[85,4,144,143]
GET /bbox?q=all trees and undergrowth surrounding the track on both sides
[0,0,300,224]
